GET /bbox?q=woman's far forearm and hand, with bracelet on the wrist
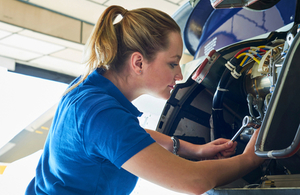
[146,129,237,160]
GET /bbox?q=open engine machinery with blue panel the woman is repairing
[157,0,300,194]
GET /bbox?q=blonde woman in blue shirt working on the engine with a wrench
[27,6,262,195]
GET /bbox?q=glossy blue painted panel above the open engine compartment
[184,0,297,58]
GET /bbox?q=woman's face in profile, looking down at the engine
[143,32,183,99]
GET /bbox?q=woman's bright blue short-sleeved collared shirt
[26,69,154,195]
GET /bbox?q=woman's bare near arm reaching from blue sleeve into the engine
[122,131,263,194]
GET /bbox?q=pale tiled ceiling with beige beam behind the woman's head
[0,0,187,76]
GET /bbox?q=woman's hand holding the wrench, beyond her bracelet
[198,138,237,160]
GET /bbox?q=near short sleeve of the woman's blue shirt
[84,106,155,168]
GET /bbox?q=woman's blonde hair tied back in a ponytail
[65,5,180,94]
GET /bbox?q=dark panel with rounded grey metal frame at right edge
[255,26,300,159]
